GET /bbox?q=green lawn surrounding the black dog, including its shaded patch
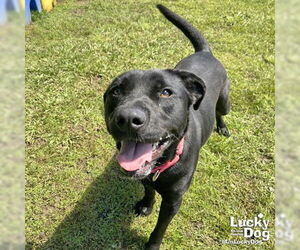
[26,0,275,249]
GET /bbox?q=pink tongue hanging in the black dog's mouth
[117,141,152,171]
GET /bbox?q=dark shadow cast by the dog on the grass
[39,159,146,249]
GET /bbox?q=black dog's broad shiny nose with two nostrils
[116,109,146,130]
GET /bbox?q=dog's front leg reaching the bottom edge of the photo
[145,196,182,250]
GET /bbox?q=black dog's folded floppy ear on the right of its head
[173,70,206,110]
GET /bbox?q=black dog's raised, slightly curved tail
[156,4,210,52]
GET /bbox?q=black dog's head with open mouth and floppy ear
[104,70,205,179]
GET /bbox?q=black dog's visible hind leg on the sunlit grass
[216,79,230,137]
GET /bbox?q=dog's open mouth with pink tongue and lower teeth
[117,136,171,172]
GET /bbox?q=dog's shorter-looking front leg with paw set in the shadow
[134,181,155,216]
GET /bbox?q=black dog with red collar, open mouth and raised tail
[104,5,230,249]
